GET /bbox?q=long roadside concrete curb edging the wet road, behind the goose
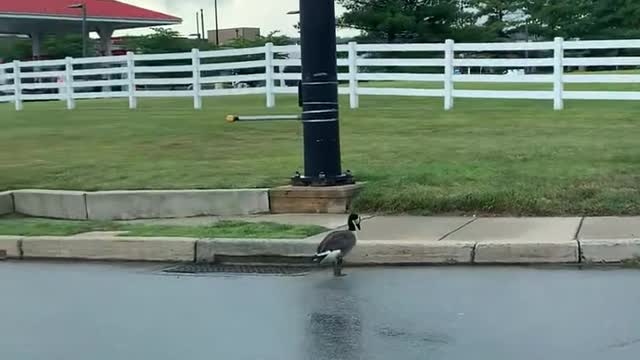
[0,234,640,265]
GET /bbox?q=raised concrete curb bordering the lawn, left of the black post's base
[0,189,270,220]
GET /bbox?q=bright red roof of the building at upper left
[0,0,181,23]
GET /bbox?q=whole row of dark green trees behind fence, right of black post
[338,0,640,42]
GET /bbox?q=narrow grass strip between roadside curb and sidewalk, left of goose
[0,217,327,239]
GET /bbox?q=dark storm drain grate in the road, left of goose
[163,264,311,276]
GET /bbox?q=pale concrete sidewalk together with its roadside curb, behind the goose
[0,215,640,265]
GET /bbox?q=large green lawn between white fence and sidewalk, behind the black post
[0,91,640,215]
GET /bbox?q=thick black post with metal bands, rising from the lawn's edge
[292,0,354,186]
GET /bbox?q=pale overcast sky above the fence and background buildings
[118,0,353,36]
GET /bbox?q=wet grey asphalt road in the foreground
[0,262,640,360]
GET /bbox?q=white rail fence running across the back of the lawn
[0,38,640,110]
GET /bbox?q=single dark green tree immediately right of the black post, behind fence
[338,0,461,43]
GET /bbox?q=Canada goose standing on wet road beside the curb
[313,214,362,276]
